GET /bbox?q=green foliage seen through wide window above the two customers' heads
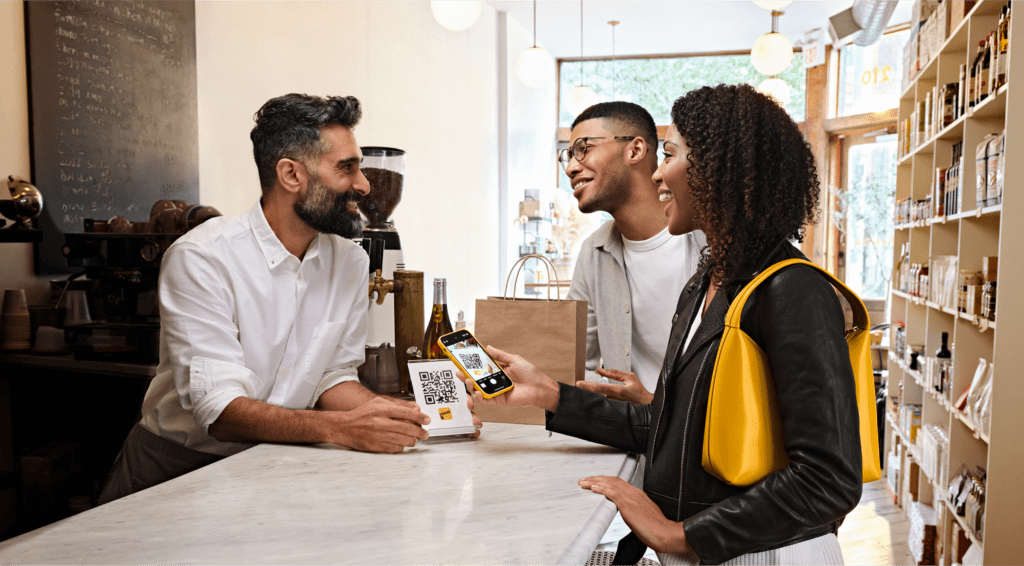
[558,53,806,127]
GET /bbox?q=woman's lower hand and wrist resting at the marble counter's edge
[580,476,693,554]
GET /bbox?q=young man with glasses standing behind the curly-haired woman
[558,101,705,403]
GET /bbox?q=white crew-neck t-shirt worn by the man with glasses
[623,228,700,392]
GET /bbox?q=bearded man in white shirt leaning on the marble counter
[99,94,430,504]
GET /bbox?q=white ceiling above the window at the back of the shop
[486,0,913,58]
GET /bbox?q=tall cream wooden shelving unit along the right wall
[886,0,1024,564]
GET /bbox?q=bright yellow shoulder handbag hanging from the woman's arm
[701,259,882,486]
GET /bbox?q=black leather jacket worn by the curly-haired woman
[547,242,862,564]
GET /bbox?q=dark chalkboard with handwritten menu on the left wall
[25,0,199,274]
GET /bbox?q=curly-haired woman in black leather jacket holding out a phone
[475,85,861,565]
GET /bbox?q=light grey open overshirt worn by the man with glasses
[566,220,706,372]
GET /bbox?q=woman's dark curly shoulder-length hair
[672,85,819,285]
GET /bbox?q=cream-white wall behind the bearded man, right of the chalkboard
[196,1,499,318]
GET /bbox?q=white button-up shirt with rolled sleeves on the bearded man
[141,203,370,455]
